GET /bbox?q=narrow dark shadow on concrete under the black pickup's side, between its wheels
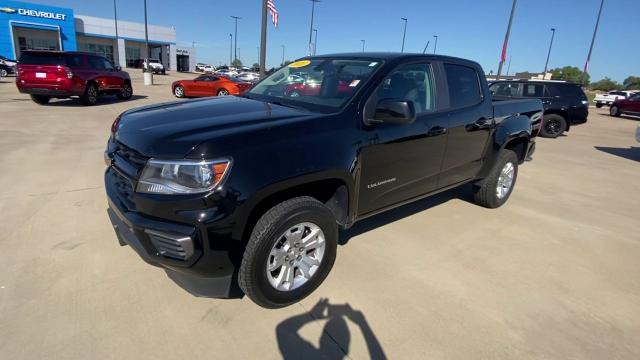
[338,184,473,245]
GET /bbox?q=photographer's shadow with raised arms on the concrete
[276,299,387,360]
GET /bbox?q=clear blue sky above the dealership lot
[33,0,640,81]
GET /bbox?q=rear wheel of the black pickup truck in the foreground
[473,149,518,209]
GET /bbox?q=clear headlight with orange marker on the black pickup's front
[136,158,232,194]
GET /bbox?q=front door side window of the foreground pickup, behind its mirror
[376,64,435,114]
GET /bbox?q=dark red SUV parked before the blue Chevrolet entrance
[16,51,133,105]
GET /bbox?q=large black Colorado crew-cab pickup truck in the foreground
[105,53,542,308]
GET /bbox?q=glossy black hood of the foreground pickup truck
[115,96,313,158]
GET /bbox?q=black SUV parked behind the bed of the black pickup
[489,80,589,138]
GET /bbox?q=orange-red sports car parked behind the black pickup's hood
[171,75,253,98]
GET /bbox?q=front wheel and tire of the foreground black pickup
[238,196,338,309]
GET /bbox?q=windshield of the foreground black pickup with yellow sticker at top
[245,58,380,112]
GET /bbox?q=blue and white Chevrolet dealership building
[0,0,196,71]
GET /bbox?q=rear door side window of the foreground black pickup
[444,64,482,108]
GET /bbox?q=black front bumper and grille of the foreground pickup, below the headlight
[105,166,238,297]
